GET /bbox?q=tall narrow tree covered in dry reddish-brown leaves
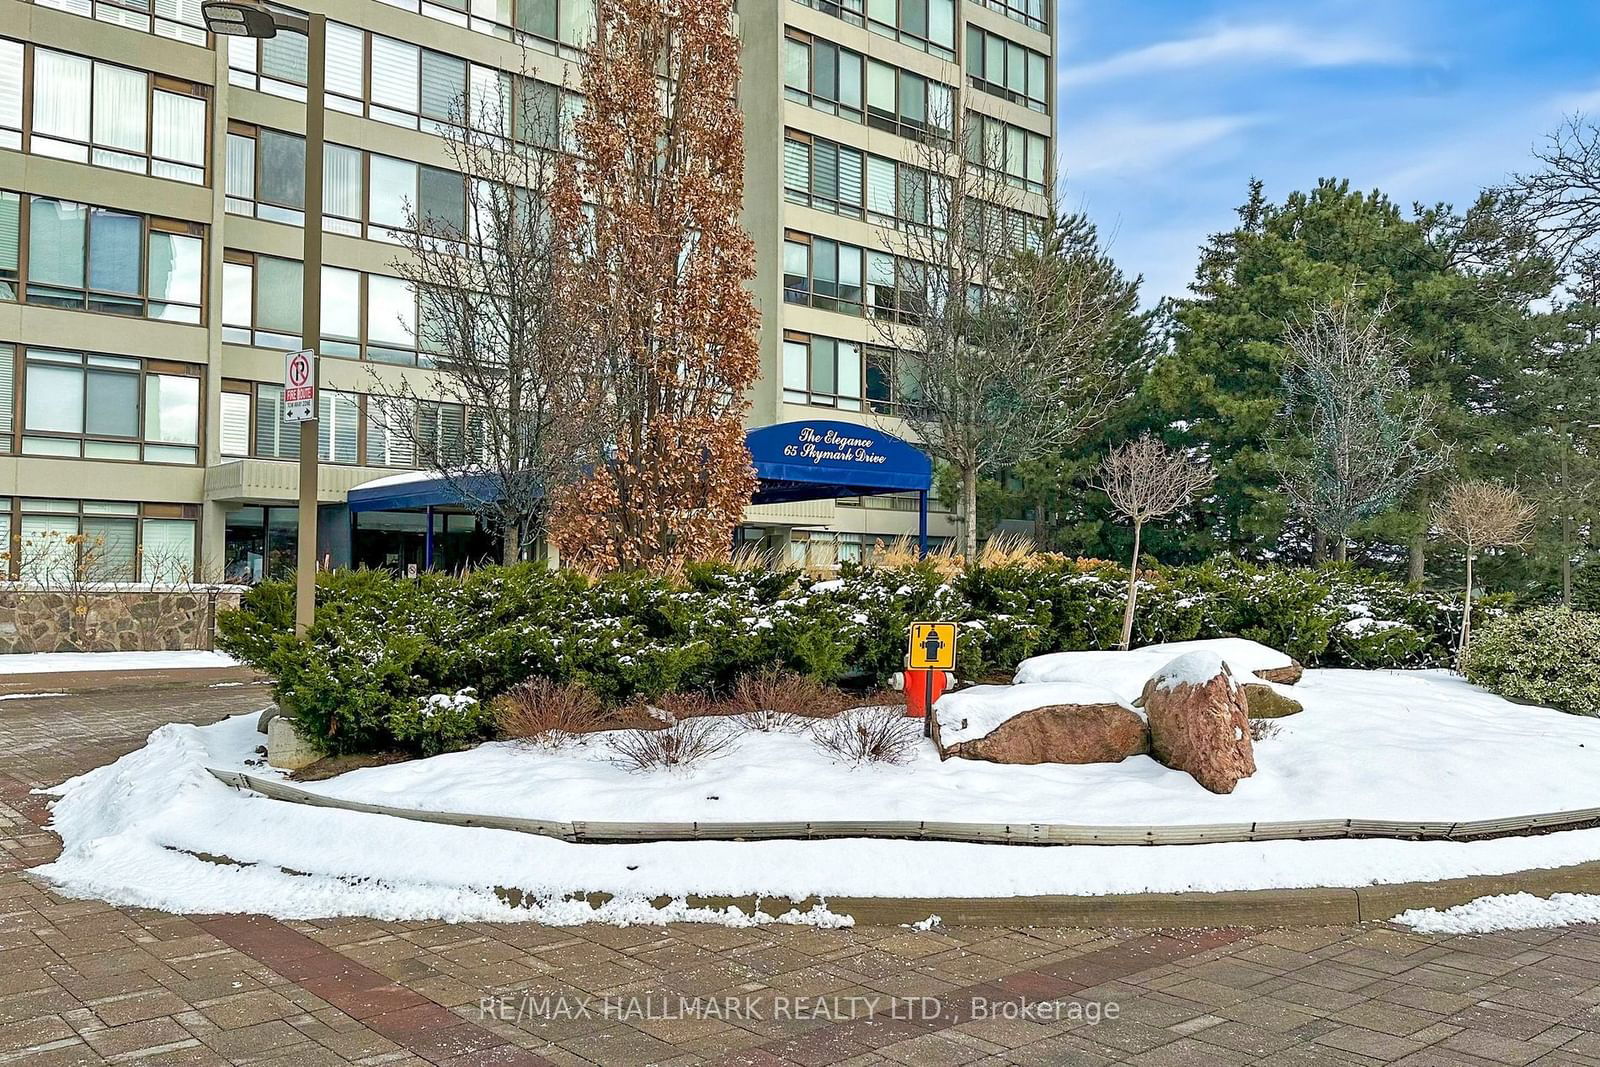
[550,0,760,571]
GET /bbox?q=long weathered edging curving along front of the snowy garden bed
[206,768,1600,845]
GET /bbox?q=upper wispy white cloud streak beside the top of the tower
[1061,22,1414,85]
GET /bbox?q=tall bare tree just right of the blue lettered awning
[866,109,1139,558]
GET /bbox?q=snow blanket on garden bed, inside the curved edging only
[275,670,1600,825]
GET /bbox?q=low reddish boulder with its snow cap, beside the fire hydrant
[933,683,1150,763]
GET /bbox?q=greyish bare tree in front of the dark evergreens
[1274,290,1448,561]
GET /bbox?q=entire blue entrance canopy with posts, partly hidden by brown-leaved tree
[347,419,933,560]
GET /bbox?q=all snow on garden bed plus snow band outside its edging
[34,672,1600,923]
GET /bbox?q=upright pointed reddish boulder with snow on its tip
[1142,649,1256,793]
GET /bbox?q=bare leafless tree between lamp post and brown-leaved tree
[370,75,581,563]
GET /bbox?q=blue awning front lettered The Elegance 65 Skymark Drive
[744,419,933,504]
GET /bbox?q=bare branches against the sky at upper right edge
[1498,115,1600,264]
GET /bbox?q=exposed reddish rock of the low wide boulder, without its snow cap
[933,704,1150,763]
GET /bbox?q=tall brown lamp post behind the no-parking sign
[200,0,328,637]
